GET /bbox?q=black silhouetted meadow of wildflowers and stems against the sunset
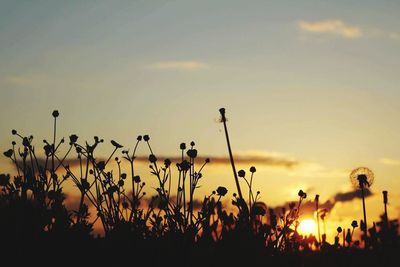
[0,109,399,266]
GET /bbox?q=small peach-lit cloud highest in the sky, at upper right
[298,20,363,38]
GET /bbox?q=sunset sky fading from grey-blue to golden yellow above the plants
[0,0,400,240]
